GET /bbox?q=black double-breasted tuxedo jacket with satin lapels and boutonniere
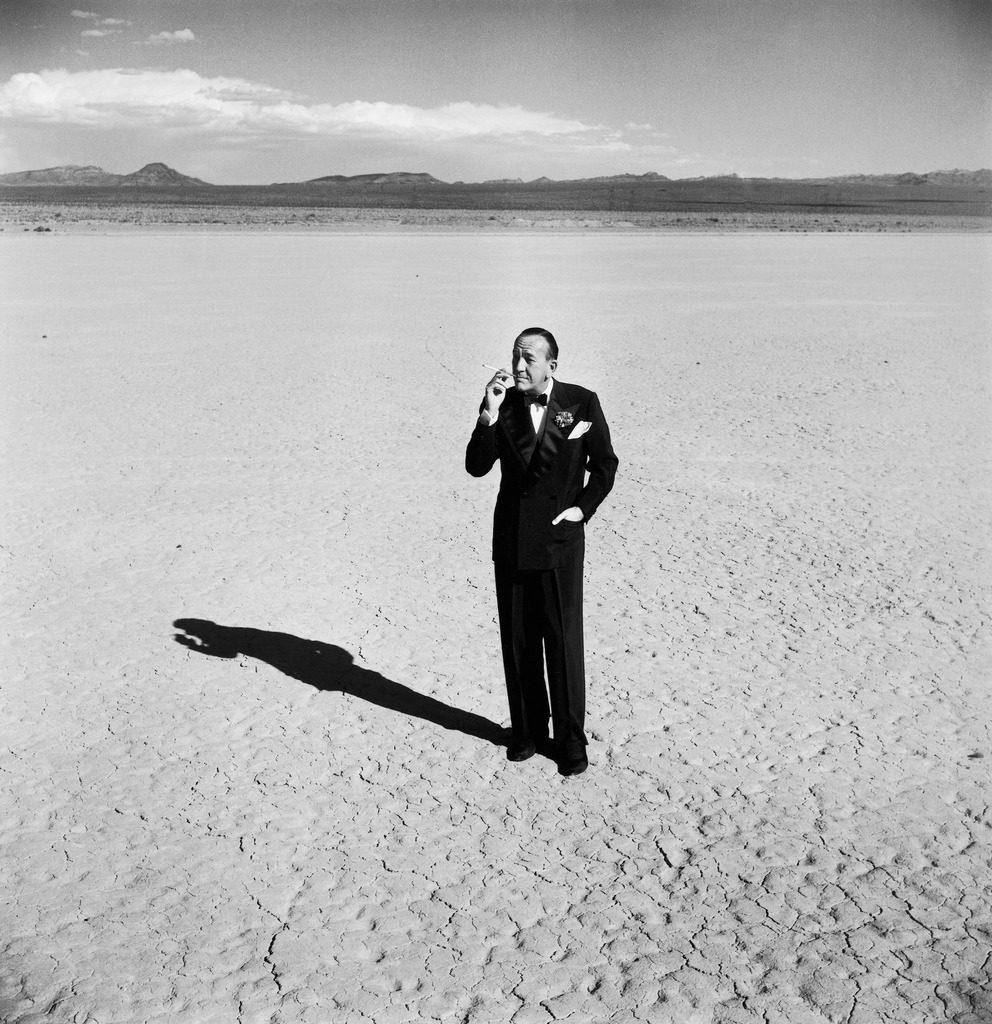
[465,380,618,570]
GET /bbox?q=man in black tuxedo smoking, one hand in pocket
[465,328,617,775]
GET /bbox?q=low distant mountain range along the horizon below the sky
[0,163,992,189]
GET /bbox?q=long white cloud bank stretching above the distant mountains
[0,69,607,144]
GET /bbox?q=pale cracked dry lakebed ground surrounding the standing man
[0,232,992,1024]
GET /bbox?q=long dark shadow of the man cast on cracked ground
[172,618,507,746]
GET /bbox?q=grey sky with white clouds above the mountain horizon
[0,0,992,184]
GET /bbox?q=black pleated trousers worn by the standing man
[495,558,586,753]
